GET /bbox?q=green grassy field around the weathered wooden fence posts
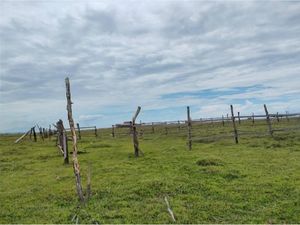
[0,119,300,223]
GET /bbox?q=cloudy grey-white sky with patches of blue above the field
[0,0,300,132]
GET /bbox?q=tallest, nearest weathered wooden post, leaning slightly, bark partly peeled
[65,77,84,202]
